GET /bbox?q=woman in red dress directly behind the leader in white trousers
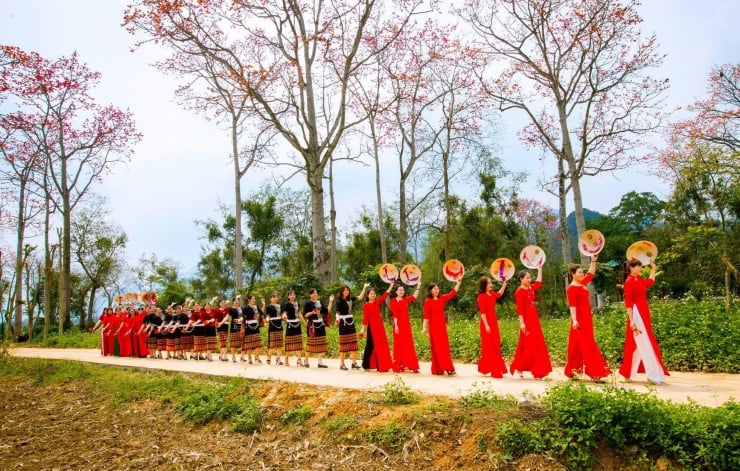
[565,254,612,381]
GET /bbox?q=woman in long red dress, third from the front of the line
[509,267,552,379]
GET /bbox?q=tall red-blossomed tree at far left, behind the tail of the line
[0,46,141,333]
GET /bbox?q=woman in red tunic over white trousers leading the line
[619,259,669,384]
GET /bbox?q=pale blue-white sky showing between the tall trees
[0,0,740,274]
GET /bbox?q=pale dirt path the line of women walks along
[10,348,740,407]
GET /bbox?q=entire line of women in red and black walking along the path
[96,255,668,384]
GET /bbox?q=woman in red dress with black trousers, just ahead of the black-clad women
[360,283,393,373]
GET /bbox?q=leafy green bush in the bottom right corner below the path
[497,383,740,470]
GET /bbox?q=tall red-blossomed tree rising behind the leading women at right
[458,0,668,262]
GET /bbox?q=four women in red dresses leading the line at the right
[488,255,669,384]
